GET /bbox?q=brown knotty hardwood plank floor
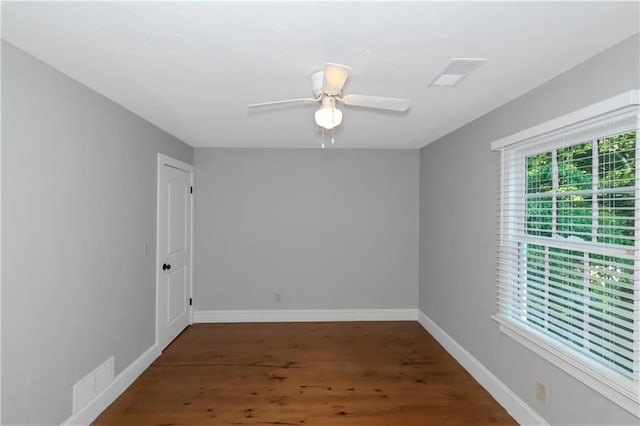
[94,321,516,426]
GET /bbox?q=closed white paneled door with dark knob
[156,154,193,350]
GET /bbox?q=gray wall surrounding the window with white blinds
[420,35,640,425]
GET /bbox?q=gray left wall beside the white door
[2,42,193,425]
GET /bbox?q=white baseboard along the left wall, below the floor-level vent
[62,345,161,426]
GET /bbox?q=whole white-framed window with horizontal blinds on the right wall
[493,92,640,417]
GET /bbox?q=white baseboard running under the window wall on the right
[418,311,549,425]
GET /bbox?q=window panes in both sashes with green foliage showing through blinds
[521,131,636,373]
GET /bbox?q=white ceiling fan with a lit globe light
[248,63,410,130]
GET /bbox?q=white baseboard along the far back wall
[193,309,418,322]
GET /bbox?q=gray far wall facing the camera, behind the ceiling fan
[194,148,419,310]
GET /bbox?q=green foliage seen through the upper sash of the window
[526,131,636,246]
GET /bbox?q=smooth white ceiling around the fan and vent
[2,1,640,148]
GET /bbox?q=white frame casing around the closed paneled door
[155,153,195,352]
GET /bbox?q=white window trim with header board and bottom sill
[491,90,640,418]
